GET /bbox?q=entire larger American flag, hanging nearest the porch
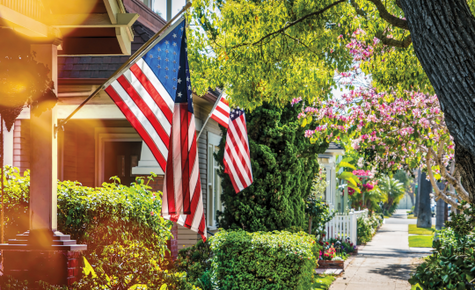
[105,20,206,240]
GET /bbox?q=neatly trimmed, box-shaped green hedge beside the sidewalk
[210,230,320,290]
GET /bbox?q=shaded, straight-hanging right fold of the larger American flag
[162,24,206,241]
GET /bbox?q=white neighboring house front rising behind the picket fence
[318,142,345,210]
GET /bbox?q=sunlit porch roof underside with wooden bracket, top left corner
[0,0,138,55]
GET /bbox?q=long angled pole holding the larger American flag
[55,1,191,132]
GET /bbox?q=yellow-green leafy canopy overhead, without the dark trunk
[190,0,433,109]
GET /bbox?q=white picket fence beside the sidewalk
[325,209,368,245]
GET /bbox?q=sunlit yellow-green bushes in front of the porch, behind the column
[2,168,196,289]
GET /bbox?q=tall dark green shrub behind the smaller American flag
[215,104,328,232]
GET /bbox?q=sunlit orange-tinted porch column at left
[30,44,58,247]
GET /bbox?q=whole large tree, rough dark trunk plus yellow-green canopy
[190,0,475,201]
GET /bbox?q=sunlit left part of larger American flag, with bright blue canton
[105,20,185,172]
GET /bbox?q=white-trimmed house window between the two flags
[206,132,223,230]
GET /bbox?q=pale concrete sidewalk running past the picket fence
[330,210,430,290]
